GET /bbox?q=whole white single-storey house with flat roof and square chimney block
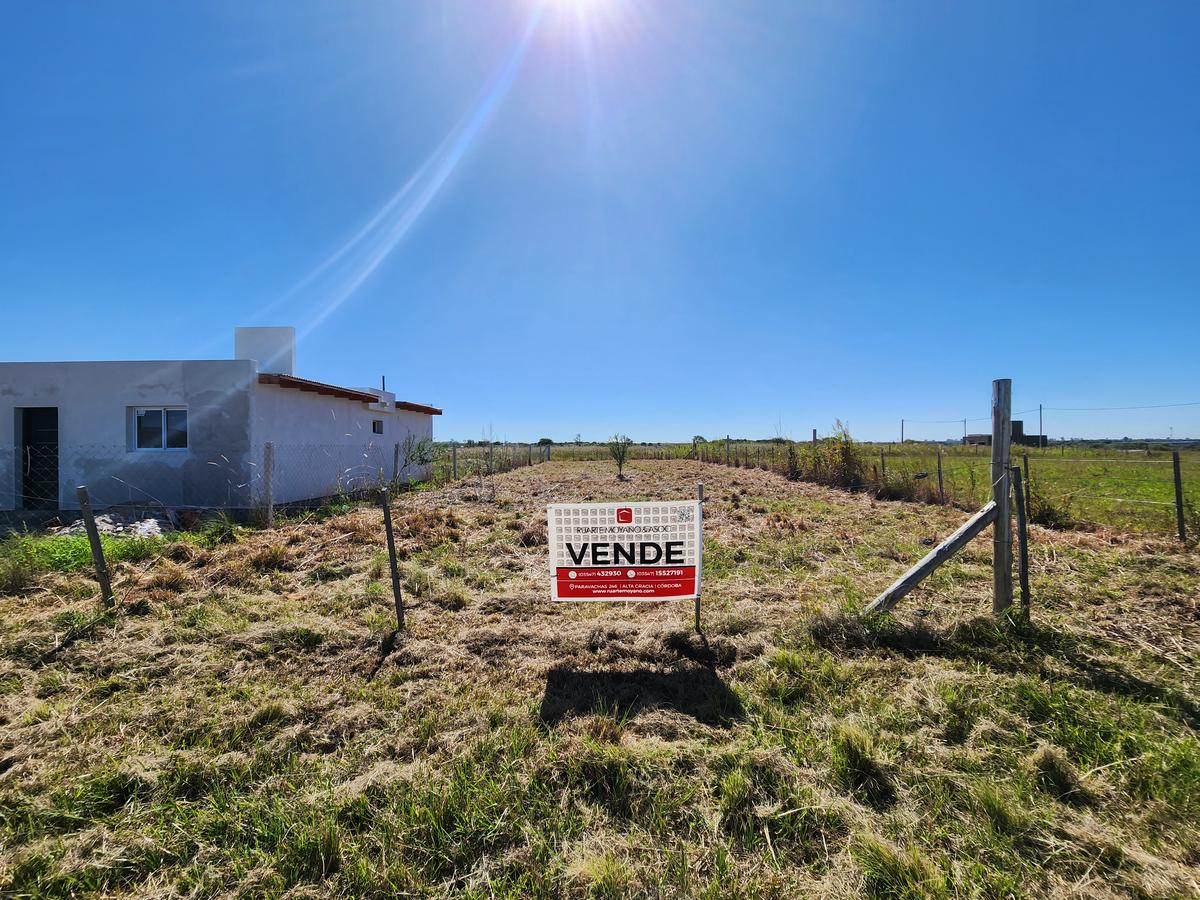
[0,328,442,510]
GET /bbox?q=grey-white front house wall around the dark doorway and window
[0,360,256,509]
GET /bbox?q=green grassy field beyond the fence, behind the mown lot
[438,440,1200,534]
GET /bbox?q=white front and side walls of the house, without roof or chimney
[0,352,433,510]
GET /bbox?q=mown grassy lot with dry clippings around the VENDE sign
[0,461,1200,898]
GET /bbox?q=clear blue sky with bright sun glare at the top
[0,0,1200,440]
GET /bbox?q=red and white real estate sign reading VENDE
[548,500,703,600]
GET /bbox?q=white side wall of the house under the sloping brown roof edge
[251,384,433,503]
